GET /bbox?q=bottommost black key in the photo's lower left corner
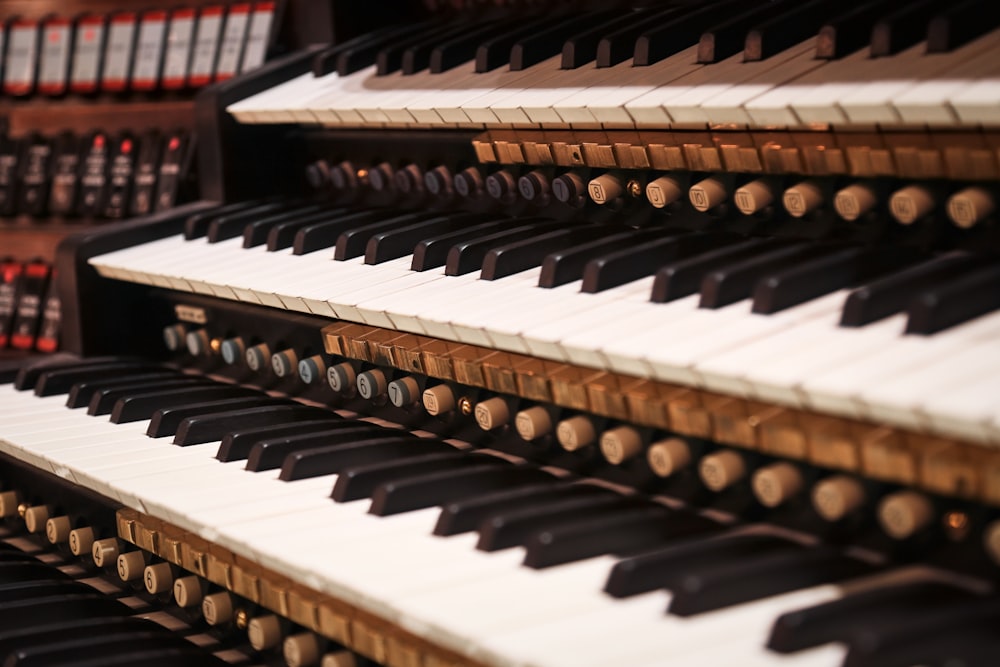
[4,630,199,667]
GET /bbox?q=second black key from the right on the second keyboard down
[840,252,986,327]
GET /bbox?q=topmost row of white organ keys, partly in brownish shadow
[229,28,1000,129]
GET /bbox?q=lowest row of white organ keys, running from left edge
[0,386,960,667]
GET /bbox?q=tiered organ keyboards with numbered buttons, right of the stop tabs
[0,0,1000,667]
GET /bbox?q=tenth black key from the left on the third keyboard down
[278,434,459,482]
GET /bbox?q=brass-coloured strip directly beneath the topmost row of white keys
[472,128,1000,181]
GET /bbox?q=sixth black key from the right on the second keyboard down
[580,232,740,293]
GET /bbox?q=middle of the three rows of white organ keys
[86,228,1000,442]
